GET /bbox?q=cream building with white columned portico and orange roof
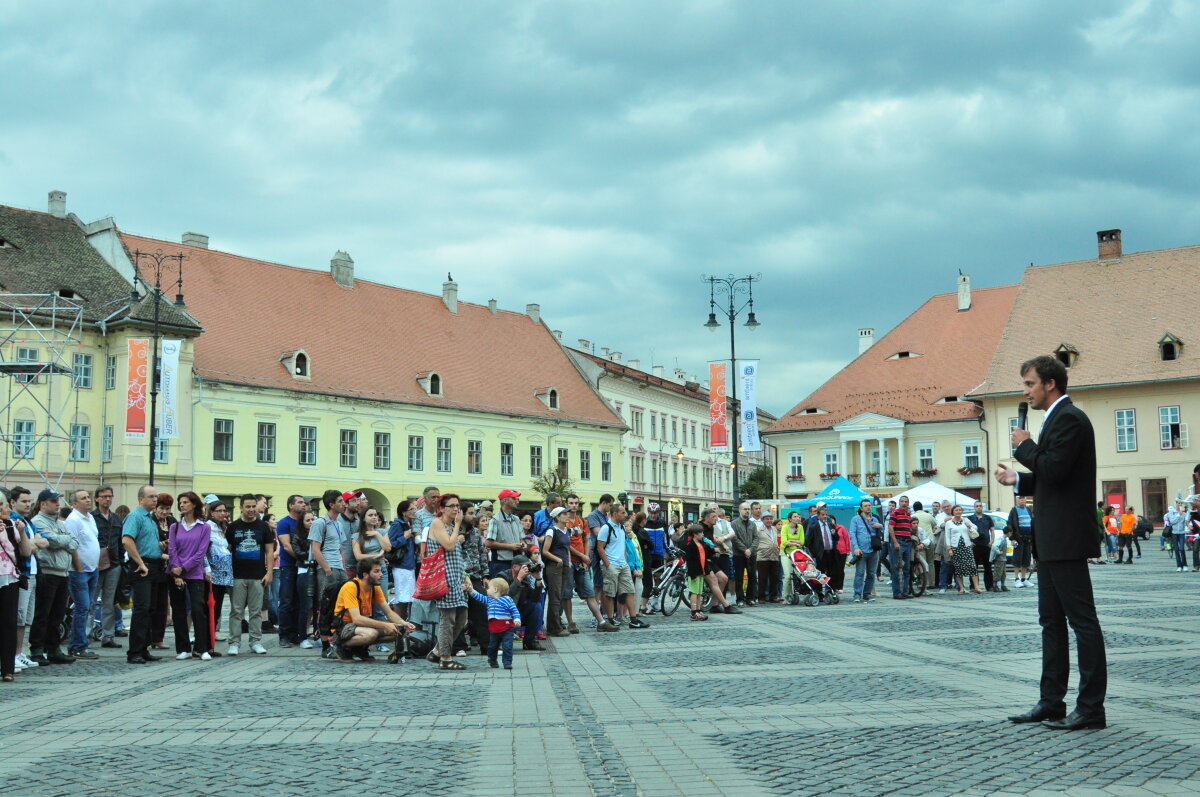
[763,274,1018,499]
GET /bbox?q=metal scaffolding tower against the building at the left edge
[0,293,87,492]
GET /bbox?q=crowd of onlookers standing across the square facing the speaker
[0,475,1200,682]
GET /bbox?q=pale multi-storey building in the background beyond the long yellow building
[568,340,775,521]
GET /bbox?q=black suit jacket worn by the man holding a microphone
[1016,397,1100,562]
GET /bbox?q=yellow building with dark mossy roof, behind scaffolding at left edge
[0,192,200,505]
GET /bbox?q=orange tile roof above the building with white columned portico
[763,284,1018,435]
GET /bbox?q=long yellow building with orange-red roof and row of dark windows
[122,226,625,516]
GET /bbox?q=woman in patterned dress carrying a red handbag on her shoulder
[413,492,467,670]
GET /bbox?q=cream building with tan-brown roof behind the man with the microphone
[970,229,1200,516]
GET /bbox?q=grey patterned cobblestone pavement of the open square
[0,554,1200,797]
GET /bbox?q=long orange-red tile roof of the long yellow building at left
[122,234,624,429]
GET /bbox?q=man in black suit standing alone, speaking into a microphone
[996,356,1108,731]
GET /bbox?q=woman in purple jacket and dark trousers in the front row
[167,492,212,661]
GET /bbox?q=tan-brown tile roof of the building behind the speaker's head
[972,240,1200,396]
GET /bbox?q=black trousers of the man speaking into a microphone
[1038,559,1109,717]
